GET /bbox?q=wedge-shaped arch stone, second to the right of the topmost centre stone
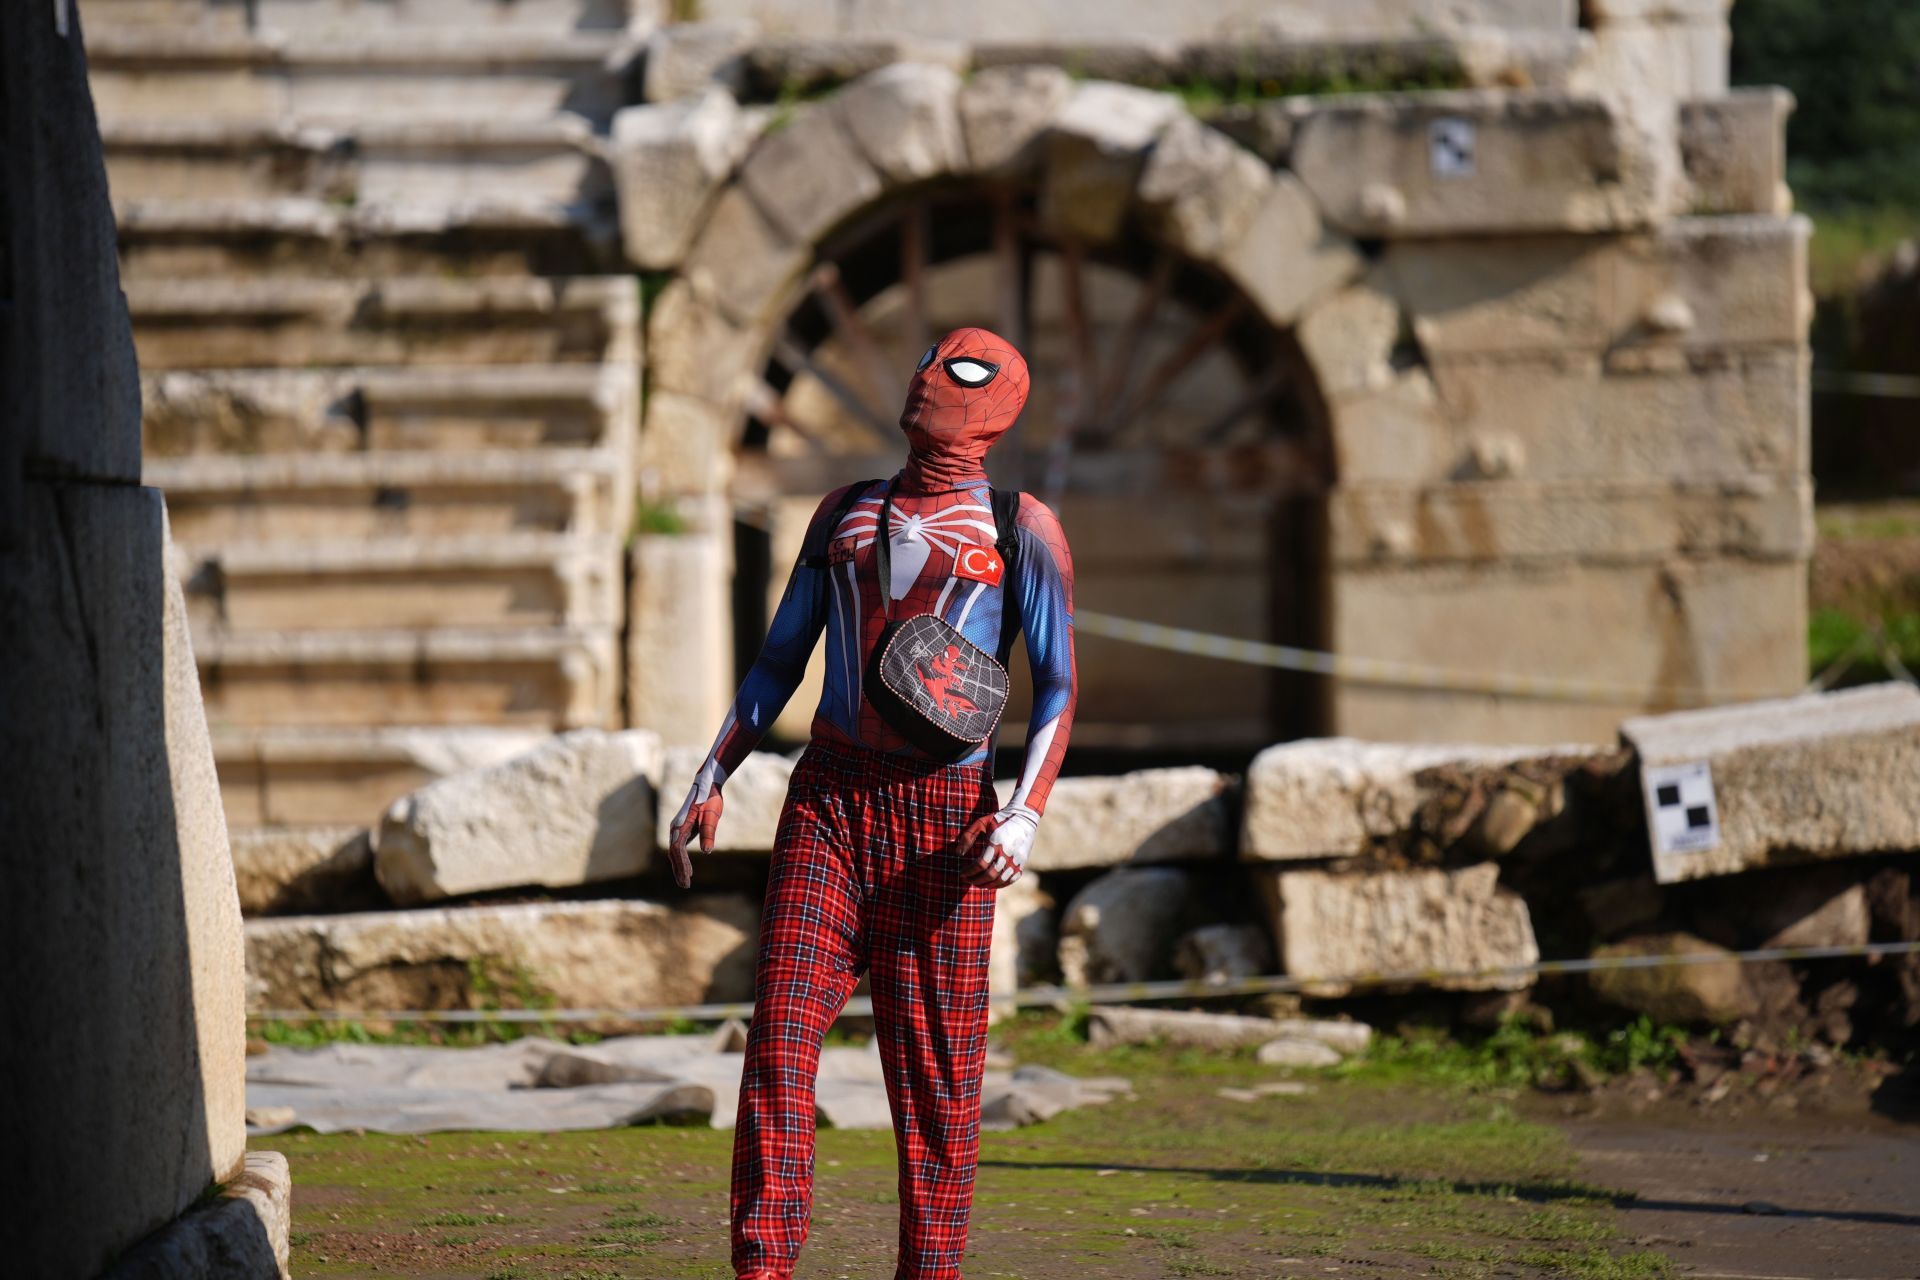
[1139,115,1271,261]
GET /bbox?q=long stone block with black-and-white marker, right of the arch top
[1292,90,1680,236]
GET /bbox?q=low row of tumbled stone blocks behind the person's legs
[248,685,1920,1044]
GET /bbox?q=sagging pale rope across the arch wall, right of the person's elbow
[1073,610,1780,706]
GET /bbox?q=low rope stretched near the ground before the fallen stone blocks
[248,942,1920,1025]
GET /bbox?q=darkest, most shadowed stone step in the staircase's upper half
[117,192,622,280]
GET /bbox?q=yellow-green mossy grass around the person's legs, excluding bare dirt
[275,1013,1667,1280]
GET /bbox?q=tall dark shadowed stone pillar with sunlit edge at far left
[0,4,286,1280]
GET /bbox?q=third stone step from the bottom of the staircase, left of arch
[175,533,626,631]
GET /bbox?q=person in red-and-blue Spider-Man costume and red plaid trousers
[668,328,1075,1280]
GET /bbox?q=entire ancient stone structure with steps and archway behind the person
[82,0,1811,821]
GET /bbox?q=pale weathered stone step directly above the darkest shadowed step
[100,115,612,213]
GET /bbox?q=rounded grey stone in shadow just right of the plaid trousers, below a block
[1060,867,1192,986]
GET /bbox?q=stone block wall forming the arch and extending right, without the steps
[614,22,1812,745]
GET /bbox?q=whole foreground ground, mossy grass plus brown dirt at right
[274,1029,1920,1280]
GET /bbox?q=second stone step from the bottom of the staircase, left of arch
[194,628,620,731]
